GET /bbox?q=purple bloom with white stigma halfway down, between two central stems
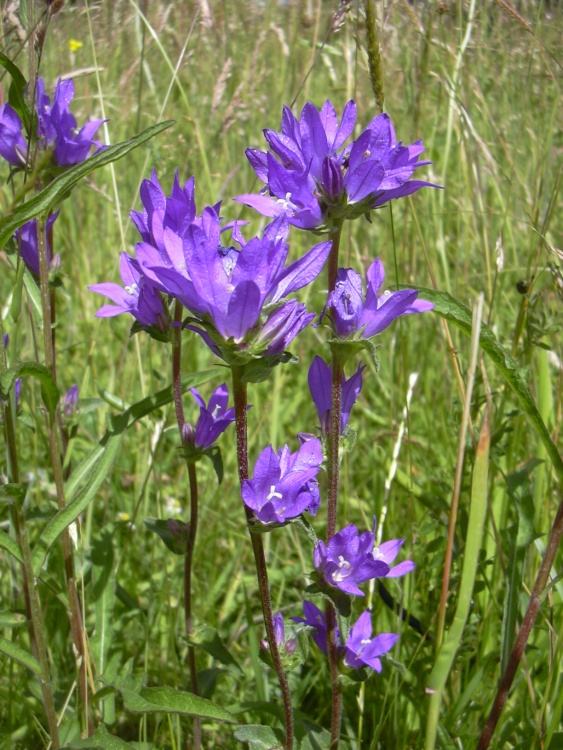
[242,439,323,523]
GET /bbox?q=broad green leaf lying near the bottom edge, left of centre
[116,676,236,724]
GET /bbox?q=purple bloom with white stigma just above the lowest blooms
[313,524,389,596]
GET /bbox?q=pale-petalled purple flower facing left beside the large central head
[88,253,168,331]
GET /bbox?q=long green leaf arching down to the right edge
[415,287,563,482]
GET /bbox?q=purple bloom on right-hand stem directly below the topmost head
[327,258,434,339]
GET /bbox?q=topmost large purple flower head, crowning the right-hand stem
[235,100,439,230]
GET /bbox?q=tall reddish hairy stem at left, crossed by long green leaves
[37,217,88,735]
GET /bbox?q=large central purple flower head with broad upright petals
[137,207,330,356]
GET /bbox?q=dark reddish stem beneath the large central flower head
[231,365,294,750]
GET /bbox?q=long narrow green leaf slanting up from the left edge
[0,120,174,249]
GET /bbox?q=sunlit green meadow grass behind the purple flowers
[0,0,563,750]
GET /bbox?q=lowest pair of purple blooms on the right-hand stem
[291,602,399,672]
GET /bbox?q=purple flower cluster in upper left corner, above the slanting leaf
[0,78,104,167]
